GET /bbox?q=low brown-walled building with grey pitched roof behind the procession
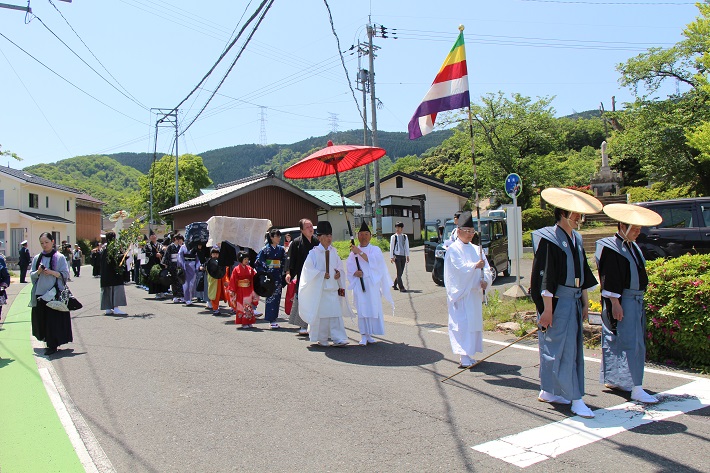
[159,171,331,236]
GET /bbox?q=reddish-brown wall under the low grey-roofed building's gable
[174,186,318,231]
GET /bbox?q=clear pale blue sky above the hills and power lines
[0,0,698,168]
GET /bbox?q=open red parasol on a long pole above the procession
[284,140,386,292]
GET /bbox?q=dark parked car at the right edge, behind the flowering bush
[636,197,710,259]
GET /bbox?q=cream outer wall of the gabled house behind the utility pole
[350,177,466,227]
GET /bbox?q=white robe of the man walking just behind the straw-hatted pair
[444,240,493,356]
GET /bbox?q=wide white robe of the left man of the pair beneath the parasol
[298,245,354,344]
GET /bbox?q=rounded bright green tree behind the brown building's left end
[139,154,212,222]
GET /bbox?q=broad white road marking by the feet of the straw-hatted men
[471,379,710,468]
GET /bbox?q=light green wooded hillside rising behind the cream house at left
[25,155,147,214]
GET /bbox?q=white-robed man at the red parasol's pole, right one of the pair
[346,222,394,346]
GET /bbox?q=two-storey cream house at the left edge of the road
[0,162,82,261]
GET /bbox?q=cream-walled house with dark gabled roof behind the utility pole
[347,171,470,238]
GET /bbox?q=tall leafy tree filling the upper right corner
[609,2,710,195]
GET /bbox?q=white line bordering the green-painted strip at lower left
[32,337,116,473]
